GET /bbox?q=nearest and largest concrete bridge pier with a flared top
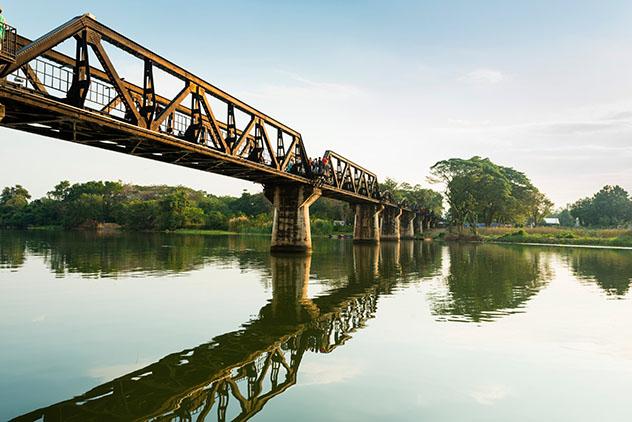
[264,184,320,252]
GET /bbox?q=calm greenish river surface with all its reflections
[0,232,632,422]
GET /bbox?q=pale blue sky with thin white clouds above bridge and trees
[0,0,632,206]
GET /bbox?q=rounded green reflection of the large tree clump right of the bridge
[430,244,552,322]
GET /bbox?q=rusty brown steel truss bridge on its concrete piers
[0,14,420,251]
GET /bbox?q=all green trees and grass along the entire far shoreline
[0,156,632,252]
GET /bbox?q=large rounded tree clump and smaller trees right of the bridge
[429,156,632,231]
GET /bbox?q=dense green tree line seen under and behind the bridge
[0,179,441,234]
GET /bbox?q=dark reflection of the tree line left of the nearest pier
[0,231,269,277]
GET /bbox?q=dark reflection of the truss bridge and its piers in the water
[16,242,432,421]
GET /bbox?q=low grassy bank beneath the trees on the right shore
[471,227,632,247]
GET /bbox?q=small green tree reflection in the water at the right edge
[563,248,632,297]
